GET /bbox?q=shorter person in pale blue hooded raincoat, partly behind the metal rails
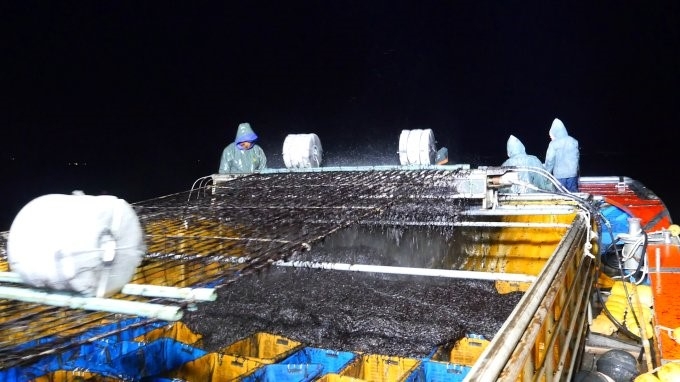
[502,135,552,193]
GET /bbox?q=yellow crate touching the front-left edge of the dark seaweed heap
[219,332,302,364]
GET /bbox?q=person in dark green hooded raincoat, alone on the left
[219,122,267,174]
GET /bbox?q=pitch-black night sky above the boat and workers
[0,0,680,230]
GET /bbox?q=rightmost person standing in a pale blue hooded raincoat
[543,118,579,192]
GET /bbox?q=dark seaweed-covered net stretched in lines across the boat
[0,170,466,368]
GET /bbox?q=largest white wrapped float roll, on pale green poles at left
[7,193,146,297]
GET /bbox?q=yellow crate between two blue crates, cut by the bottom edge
[339,354,420,382]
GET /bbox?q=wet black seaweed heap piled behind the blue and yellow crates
[184,267,521,357]
